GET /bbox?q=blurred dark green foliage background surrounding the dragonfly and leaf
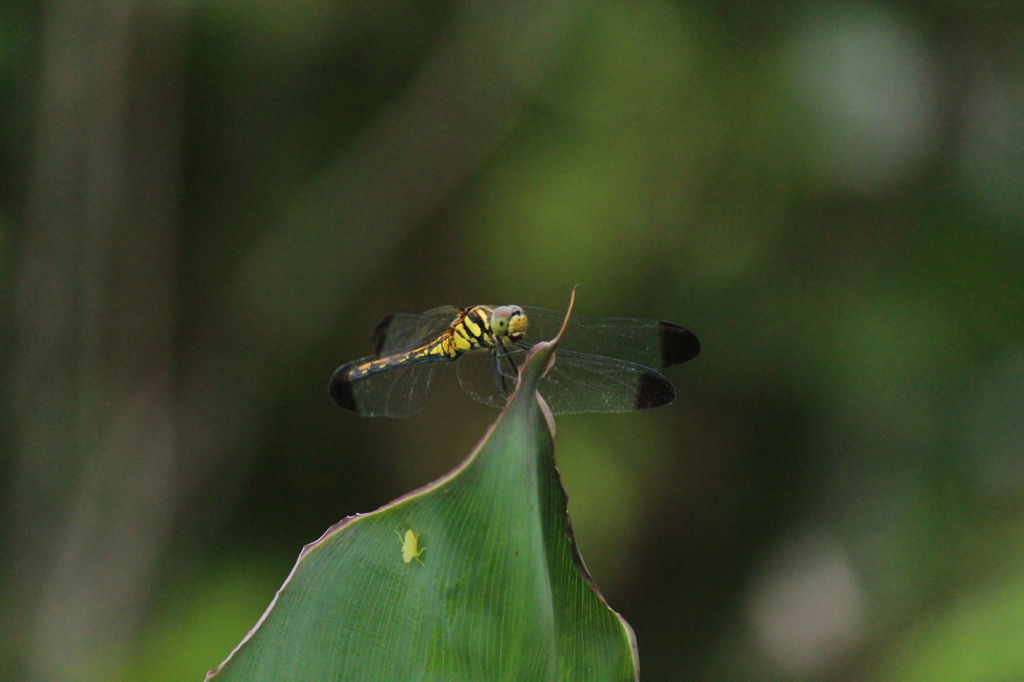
[0,0,1024,682]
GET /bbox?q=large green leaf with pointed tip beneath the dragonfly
[208,303,638,682]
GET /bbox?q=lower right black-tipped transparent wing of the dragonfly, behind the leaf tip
[459,348,676,415]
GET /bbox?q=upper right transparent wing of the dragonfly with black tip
[523,307,700,370]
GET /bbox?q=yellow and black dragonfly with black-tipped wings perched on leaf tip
[329,305,700,418]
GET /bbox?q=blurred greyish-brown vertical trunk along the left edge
[2,0,184,680]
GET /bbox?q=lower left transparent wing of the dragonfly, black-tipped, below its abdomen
[330,355,446,418]
